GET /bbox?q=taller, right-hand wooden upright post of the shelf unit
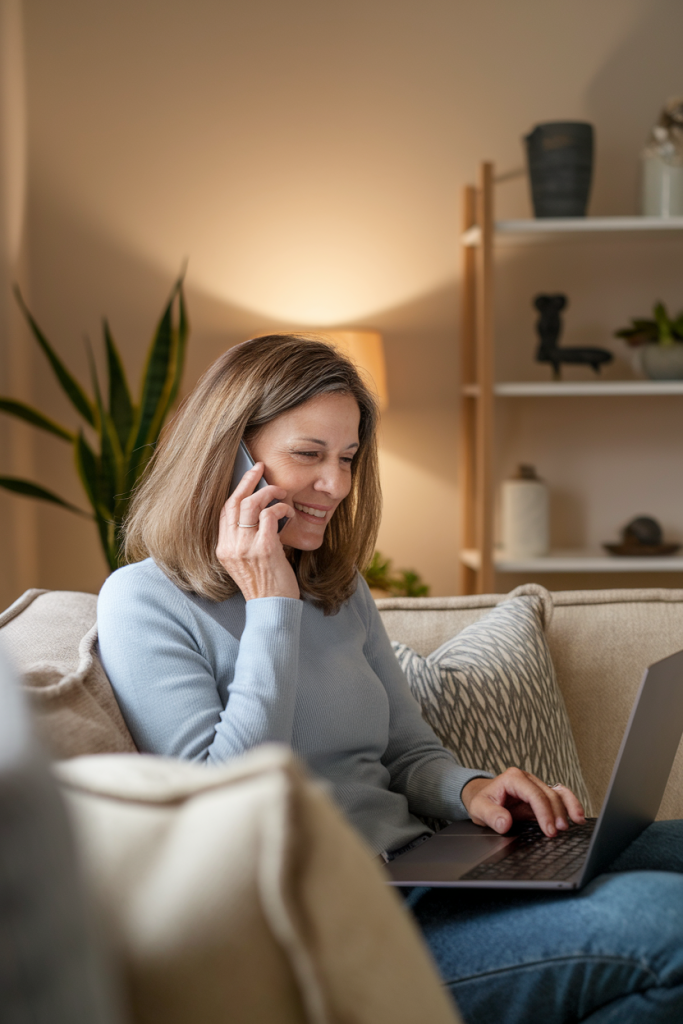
[475,163,496,594]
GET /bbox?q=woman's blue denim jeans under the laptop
[404,821,683,1024]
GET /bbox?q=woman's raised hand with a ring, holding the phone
[216,462,301,601]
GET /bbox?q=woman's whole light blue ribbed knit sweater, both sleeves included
[97,559,487,852]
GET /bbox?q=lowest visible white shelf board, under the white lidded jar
[460,549,683,572]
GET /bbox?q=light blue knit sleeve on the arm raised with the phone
[97,563,302,763]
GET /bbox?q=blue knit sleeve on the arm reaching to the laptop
[358,579,494,820]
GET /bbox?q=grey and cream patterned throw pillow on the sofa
[392,584,591,813]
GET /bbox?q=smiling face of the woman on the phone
[249,394,360,551]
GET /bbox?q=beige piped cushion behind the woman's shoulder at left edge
[0,590,135,758]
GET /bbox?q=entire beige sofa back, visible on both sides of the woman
[0,589,683,818]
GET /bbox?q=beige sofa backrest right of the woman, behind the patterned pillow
[377,588,683,818]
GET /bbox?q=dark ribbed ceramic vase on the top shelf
[524,121,593,217]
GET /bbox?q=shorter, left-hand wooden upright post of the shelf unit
[458,185,477,594]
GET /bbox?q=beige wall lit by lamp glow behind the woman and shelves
[0,0,683,603]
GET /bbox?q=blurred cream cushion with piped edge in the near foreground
[55,746,459,1024]
